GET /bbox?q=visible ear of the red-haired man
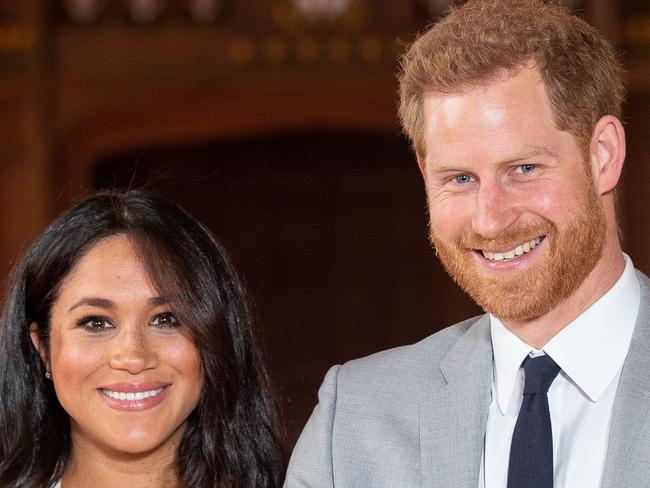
[590,115,625,195]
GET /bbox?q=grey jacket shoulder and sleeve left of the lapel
[285,317,485,488]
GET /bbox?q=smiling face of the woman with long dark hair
[31,236,203,454]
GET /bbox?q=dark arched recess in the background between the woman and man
[97,133,476,454]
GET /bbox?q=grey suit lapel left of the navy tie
[420,315,493,488]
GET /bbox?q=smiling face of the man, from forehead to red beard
[420,68,606,320]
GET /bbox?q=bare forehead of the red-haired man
[424,70,576,166]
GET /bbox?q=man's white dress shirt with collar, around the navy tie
[479,256,641,488]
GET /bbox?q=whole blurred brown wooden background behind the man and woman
[0,0,650,458]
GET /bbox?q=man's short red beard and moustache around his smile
[430,178,606,320]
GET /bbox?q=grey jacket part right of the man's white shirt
[602,273,650,488]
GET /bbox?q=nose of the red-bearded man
[472,180,519,239]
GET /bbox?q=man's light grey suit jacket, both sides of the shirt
[284,272,650,488]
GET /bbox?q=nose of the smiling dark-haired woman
[110,325,157,374]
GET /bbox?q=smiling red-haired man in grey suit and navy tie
[285,0,650,488]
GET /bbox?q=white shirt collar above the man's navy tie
[490,255,641,415]
